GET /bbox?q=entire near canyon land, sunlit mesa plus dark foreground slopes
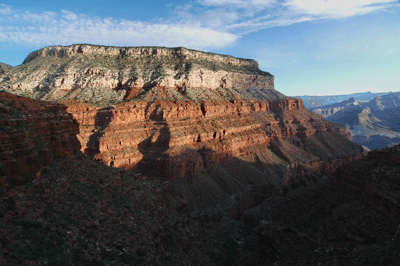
[0,45,400,265]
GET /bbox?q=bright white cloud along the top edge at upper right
[193,0,398,35]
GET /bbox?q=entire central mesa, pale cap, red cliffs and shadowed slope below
[0,45,361,216]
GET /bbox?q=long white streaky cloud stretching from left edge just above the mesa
[0,6,238,49]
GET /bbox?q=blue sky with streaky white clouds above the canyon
[0,0,400,96]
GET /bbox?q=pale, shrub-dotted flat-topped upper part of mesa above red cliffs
[0,44,278,107]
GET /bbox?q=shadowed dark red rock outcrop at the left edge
[0,92,80,189]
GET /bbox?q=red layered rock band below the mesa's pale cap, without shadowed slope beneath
[68,98,361,182]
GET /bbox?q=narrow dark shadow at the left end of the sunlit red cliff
[83,107,114,158]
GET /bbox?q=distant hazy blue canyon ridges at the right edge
[303,92,400,150]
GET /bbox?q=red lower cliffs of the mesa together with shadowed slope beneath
[68,99,362,216]
